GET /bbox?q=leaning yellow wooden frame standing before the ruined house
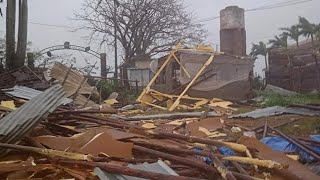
[137,41,222,111]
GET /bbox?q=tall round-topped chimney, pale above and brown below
[220,6,246,56]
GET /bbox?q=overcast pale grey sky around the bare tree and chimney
[0,0,320,76]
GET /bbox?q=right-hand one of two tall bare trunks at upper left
[15,0,28,67]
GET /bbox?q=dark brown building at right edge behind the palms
[266,41,320,93]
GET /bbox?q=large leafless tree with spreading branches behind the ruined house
[75,0,206,78]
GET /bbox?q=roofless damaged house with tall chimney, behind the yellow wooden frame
[134,6,254,101]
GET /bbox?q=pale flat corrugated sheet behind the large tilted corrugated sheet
[1,86,72,105]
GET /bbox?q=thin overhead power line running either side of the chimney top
[197,0,312,23]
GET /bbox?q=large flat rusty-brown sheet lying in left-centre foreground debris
[35,128,134,158]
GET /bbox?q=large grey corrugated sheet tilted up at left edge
[0,84,65,155]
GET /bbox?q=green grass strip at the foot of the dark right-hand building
[261,93,320,107]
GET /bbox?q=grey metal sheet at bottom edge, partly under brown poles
[94,160,179,180]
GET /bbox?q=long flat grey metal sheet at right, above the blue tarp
[229,106,320,119]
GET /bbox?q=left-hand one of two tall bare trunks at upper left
[6,0,16,69]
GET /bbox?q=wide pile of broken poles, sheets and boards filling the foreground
[0,64,320,180]
